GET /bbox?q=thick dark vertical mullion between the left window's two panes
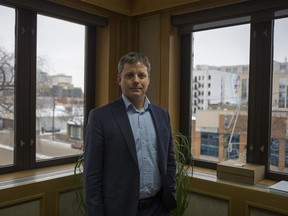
[15,9,34,169]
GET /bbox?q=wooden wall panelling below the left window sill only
[0,169,79,216]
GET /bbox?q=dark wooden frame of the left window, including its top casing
[0,0,108,174]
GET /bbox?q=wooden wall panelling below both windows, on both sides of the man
[0,172,288,216]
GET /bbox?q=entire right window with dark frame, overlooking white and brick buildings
[172,0,288,180]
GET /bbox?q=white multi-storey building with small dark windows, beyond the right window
[192,65,248,114]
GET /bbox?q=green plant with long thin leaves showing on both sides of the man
[74,132,193,216]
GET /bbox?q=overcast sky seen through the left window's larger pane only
[37,15,85,90]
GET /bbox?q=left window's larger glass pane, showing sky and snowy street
[36,15,85,161]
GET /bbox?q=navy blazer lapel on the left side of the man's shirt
[112,98,138,166]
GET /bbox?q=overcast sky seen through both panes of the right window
[194,18,288,66]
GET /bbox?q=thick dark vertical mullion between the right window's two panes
[247,21,272,164]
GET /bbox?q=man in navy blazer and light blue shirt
[84,52,176,216]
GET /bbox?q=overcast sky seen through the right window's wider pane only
[193,24,250,66]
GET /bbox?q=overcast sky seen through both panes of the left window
[0,6,85,90]
